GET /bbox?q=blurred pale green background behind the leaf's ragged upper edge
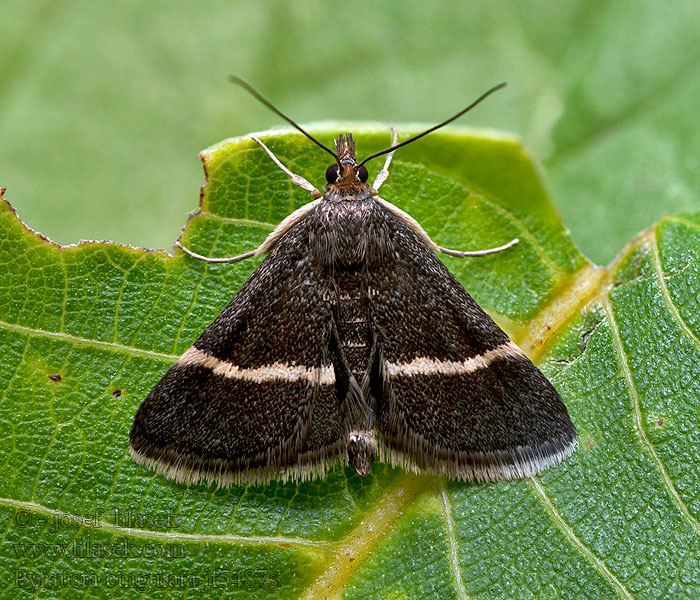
[0,0,700,264]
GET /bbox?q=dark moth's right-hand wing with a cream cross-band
[368,209,576,480]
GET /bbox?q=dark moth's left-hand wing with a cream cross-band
[130,222,344,485]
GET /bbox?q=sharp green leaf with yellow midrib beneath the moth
[0,125,700,599]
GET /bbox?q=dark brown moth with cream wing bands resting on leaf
[130,78,576,486]
